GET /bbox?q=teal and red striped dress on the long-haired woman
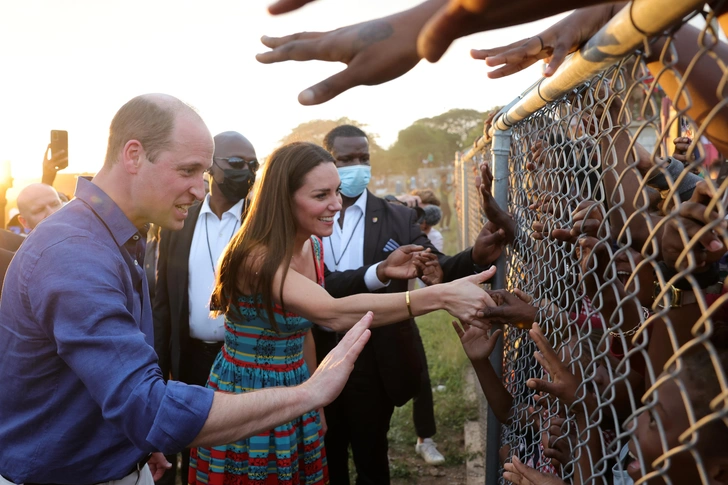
[189,237,329,485]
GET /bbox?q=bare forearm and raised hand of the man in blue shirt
[189,314,372,447]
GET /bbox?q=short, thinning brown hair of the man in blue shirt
[104,95,185,167]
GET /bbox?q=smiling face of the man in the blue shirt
[132,115,213,230]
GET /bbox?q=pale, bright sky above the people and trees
[0,0,557,189]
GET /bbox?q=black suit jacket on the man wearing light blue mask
[326,192,474,406]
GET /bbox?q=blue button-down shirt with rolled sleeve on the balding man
[0,179,213,484]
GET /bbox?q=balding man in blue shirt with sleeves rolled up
[0,94,371,485]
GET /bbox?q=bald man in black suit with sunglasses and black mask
[154,131,258,483]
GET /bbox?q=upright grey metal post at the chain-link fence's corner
[485,130,511,485]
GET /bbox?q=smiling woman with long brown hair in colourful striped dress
[189,143,495,485]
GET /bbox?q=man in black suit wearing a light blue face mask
[314,125,510,485]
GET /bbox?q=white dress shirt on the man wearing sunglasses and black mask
[187,194,245,342]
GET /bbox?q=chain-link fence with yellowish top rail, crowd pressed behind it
[456,1,728,484]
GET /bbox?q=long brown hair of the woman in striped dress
[211,142,334,332]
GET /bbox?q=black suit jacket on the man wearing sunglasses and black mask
[152,204,202,379]
